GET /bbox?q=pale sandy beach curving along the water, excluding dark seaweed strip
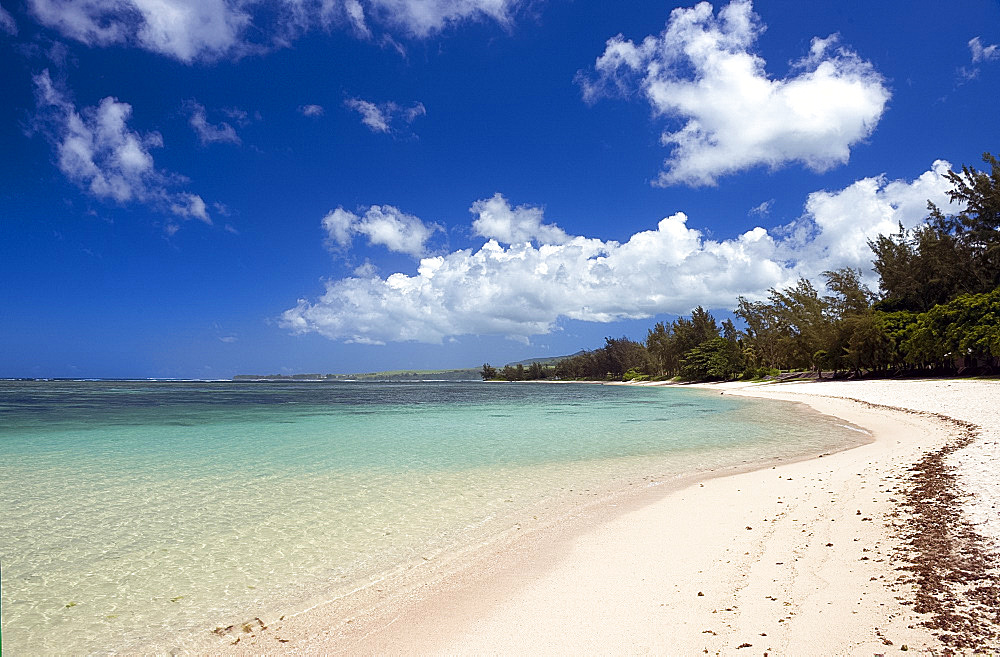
[219,381,1000,655]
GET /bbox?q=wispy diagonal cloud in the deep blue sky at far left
[33,69,211,223]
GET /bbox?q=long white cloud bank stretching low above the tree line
[281,161,950,343]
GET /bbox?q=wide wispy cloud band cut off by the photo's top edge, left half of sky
[24,0,521,63]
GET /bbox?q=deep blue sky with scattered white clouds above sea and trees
[0,0,1000,378]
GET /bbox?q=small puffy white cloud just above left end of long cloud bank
[322,205,443,258]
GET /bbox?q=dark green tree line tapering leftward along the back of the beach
[481,153,1000,381]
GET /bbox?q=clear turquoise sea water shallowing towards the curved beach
[0,382,858,654]
